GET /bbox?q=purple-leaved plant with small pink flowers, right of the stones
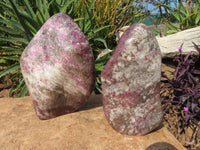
[161,43,200,147]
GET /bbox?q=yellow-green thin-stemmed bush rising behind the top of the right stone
[92,0,145,49]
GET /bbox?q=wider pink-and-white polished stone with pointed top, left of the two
[20,13,95,119]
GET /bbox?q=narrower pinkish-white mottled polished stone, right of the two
[101,24,163,135]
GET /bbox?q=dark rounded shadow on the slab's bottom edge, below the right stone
[145,142,178,150]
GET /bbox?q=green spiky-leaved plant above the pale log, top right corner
[164,0,200,33]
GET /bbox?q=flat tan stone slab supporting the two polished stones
[0,95,184,150]
